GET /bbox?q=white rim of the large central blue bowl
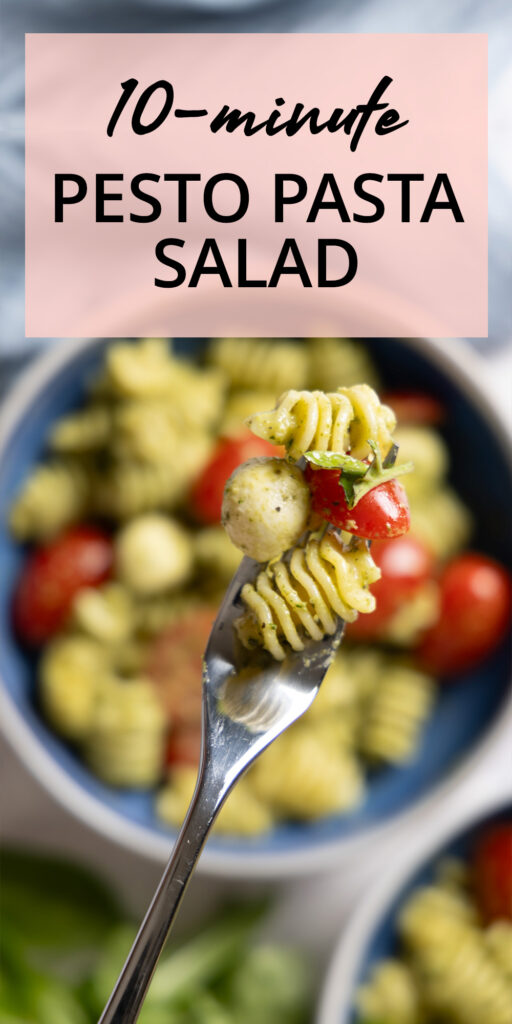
[0,338,512,881]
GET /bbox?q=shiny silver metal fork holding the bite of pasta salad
[98,558,344,1024]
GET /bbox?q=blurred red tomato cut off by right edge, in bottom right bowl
[473,822,512,924]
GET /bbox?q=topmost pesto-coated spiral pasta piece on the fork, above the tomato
[248,384,396,461]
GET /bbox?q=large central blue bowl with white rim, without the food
[0,339,512,878]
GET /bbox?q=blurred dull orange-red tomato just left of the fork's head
[145,606,217,728]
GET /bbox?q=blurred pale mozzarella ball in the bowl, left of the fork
[116,513,193,595]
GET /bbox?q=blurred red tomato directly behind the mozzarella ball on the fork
[190,431,283,523]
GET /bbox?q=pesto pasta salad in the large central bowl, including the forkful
[10,338,510,837]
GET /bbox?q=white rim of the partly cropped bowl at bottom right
[315,791,512,1024]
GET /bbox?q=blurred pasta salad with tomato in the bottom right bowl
[356,821,512,1024]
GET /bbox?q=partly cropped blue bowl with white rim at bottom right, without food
[317,801,512,1024]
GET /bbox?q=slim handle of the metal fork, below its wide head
[98,766,226,1024]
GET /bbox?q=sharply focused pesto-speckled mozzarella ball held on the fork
[222,458,310,562]
